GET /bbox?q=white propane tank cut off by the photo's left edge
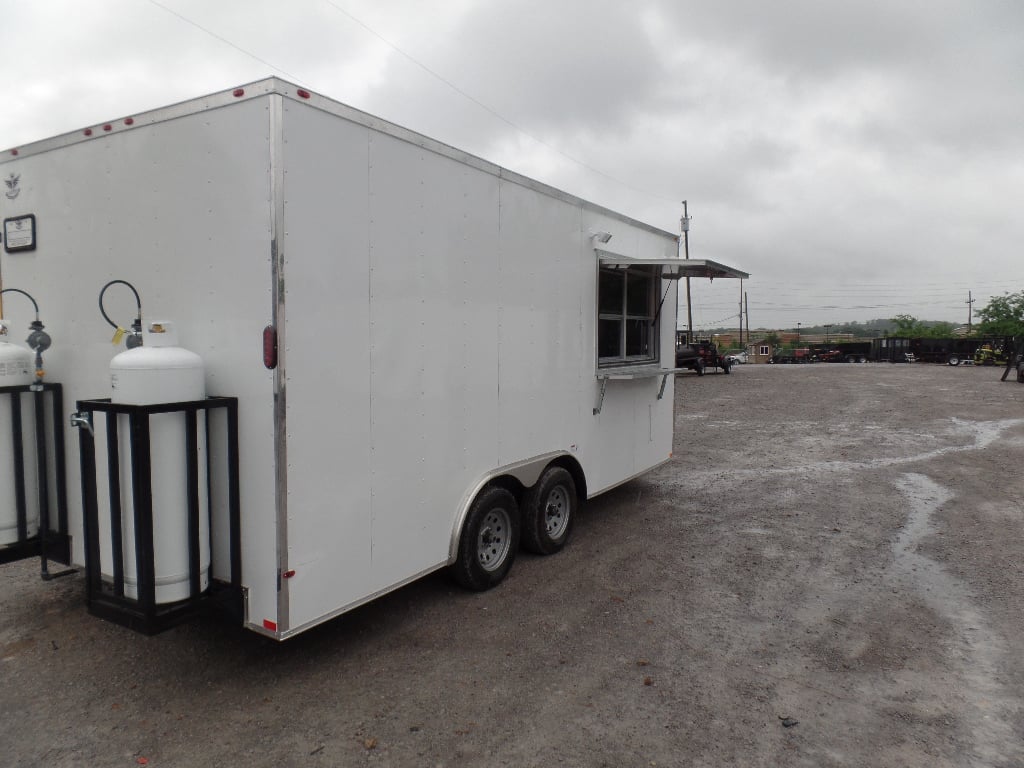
[0,331,39,546]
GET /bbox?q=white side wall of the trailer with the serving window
[279,100,675,633]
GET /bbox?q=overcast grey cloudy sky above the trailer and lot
[0,0,1024,329]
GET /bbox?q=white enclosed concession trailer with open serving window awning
[0,79,745,639]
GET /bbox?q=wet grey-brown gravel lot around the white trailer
[0,364,1024,768]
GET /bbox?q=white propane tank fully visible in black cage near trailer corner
[111,322,210,603]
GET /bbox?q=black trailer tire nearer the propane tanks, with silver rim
[450,486,520,592]
